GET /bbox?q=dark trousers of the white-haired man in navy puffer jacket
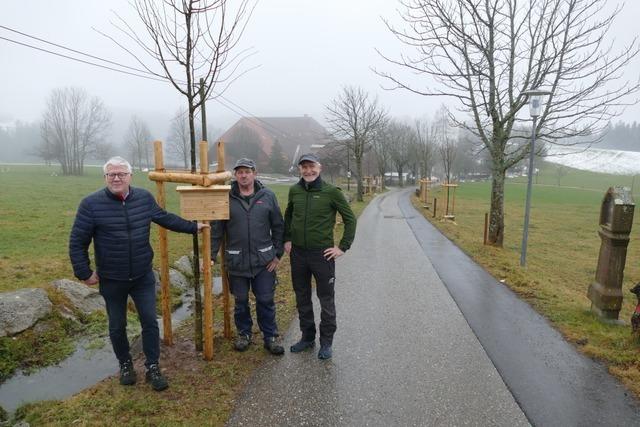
[100,271,160,367]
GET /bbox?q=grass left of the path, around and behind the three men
[0,166,368,425]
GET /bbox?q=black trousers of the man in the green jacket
[290,247,337,345]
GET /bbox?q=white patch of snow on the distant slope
[545,145,640,175]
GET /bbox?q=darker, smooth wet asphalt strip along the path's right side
[399,191,640,426]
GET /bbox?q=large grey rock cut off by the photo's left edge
[0,288,53,337]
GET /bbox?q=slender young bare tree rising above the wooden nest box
[112,0,255,172]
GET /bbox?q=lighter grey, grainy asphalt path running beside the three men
[228,191,529,426]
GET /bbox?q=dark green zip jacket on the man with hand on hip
[284,177,356,252]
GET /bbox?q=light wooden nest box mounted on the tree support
[176,185,231,221]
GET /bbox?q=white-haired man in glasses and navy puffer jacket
[69,157,209,391]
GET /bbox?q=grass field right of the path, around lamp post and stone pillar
[414,161,640,396]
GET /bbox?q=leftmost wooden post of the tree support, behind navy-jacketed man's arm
[153,141,173,346]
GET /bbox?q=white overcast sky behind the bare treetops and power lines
[0,0,640,137]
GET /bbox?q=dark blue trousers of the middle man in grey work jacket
[229,268,278,342]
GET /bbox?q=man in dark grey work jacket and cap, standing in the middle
[211,158,284,355]
